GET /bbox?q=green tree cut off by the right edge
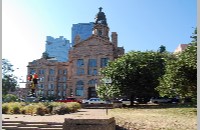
[156,29,197,103]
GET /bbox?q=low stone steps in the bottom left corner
[2,121,63,130]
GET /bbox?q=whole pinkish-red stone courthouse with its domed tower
[27,8,124,99]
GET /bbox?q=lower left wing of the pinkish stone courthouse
[26,56,69,98]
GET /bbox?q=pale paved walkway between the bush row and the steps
[2,109,109,123]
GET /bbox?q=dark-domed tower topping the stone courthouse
[93,7,109,40]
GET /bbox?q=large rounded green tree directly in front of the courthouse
[98,51,170,102]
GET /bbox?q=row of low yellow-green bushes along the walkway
[2,102,81,115]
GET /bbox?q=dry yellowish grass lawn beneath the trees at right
[108,104,197,130]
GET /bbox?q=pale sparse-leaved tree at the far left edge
[2,59,17,95]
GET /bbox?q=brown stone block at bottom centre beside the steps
[63,117,116,130]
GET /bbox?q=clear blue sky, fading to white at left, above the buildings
[2,0,197,87]
